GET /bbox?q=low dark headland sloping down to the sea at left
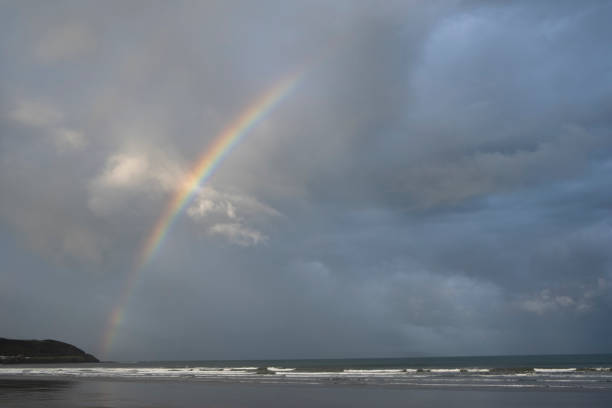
[0,337,99,364]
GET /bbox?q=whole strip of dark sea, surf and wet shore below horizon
[0,354,612,408]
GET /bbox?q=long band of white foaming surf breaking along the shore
[0,365,612,389]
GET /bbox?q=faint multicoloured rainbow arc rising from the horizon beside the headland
[101,72,303,356]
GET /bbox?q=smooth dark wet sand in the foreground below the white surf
[0,378,612,408]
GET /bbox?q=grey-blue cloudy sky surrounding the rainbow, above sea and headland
[0,0,612,360]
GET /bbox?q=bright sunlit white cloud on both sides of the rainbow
[89,148,280,246]
